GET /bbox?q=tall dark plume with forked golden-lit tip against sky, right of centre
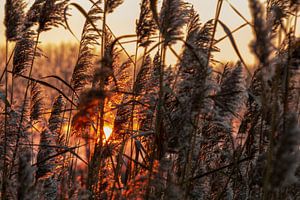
[172,14,212,130]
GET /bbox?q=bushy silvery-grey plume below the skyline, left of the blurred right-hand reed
[207,62,247,149]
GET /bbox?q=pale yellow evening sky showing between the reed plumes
[0,0,299,65]
